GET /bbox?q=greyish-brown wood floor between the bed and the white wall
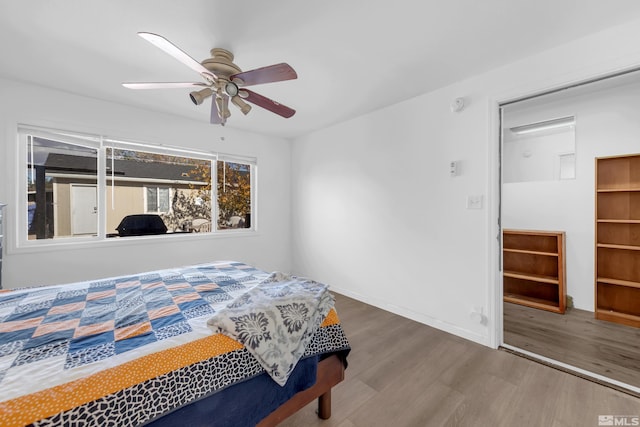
[280,294,640,427]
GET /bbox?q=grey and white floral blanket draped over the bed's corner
[207,272,335,386]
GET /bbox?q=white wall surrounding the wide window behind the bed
[0,79,291,288]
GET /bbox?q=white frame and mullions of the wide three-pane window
[11,124,258,251]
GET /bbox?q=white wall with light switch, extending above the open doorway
[292,18,640,346]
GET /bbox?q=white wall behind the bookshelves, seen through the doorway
[502,77,640,311]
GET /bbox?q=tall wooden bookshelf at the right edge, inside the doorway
[595,154,640,327]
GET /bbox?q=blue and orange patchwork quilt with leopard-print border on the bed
[0,261,349,426]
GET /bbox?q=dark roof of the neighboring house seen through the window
[44,153,208,182]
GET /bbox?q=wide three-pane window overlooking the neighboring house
[16,127,256,246]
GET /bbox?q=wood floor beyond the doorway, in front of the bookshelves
[504,303,640,387]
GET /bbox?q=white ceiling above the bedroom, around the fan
[0,0,640,138]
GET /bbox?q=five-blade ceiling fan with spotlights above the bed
[122,32,298,126]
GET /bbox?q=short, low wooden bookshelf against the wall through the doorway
[502,230,567,313]
